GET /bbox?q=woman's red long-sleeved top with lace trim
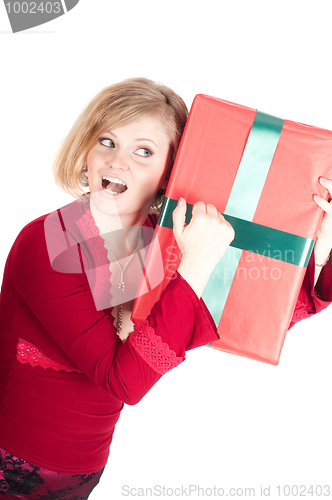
[0,198,332,474]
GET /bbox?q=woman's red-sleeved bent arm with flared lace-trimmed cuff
[8,216,218,404]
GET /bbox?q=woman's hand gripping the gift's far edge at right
[314,177,332,283]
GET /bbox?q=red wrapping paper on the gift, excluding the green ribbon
[132,95,332,364]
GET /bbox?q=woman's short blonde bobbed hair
[53,78,188,201]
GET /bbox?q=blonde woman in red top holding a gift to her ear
[0,79,332,499]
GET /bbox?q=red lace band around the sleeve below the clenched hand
[129,321,184,375]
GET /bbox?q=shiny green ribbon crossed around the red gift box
[158,111,314,325]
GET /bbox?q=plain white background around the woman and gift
[0,0,332,500]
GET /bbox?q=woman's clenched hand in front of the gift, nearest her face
[173,198,235,297]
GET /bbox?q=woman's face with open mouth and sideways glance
[87,116,170,223]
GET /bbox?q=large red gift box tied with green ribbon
[132,95,332,364]
